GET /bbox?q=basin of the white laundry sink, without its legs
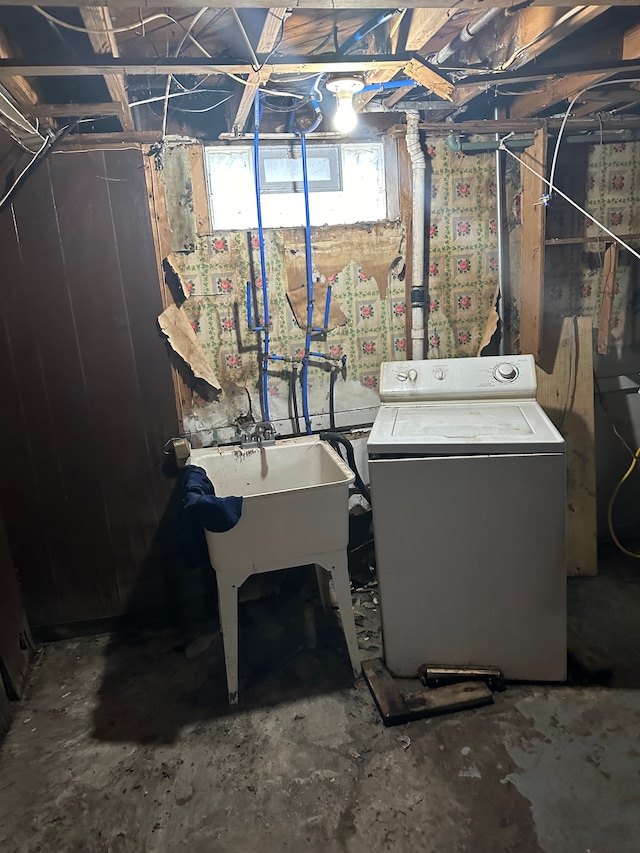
[190,437,354,575]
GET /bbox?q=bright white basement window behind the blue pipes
[205,142,398,231]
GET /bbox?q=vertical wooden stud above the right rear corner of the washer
[520,128,547,360]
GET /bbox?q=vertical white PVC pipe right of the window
[406,110,427,360]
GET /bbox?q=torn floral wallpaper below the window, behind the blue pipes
[174,223,407,417]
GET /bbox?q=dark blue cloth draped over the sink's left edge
[178,465,242,567]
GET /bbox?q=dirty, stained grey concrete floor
[0,544,640,853]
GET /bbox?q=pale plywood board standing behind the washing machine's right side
[536,317,598,575]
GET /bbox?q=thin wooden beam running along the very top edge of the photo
[0,0,624,7]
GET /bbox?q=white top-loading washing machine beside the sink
[367,355,566,681]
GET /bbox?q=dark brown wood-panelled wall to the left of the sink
[0,149,178,626]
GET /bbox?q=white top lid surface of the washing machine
[367,400,564,455]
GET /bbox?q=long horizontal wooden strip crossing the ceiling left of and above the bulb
[0,53,412,79]
